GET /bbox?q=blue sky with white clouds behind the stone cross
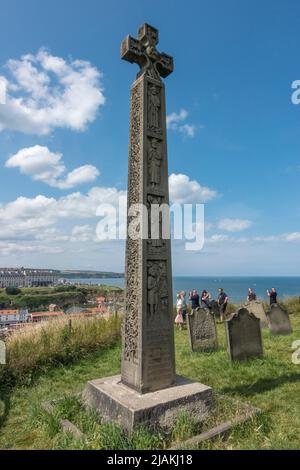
[0,0,300,275]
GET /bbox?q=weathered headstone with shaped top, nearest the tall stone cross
[187,308,218,352]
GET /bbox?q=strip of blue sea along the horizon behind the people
[70,276,300,303]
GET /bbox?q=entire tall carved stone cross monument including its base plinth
[83,24,212,430]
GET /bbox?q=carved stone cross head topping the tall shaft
[121,23,174,80]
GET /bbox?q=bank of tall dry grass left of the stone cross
[0,315,121,385]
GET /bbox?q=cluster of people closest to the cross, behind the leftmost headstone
[175,288,229,329]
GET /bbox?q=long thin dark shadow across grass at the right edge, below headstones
[222,374,300,397]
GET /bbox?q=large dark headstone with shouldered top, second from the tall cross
[225,308,263,361]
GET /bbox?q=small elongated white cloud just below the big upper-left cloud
[5,145,100,189]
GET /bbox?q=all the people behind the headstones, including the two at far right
[175,287,277,329]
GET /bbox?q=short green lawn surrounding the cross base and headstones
[0,312,300,449]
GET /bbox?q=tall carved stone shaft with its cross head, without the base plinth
[121,24,175,393]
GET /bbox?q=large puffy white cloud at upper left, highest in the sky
[0,49,105,135]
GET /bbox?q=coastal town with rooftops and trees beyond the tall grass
[0,267,122,333]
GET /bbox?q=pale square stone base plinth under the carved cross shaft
[83,375,213,433]
